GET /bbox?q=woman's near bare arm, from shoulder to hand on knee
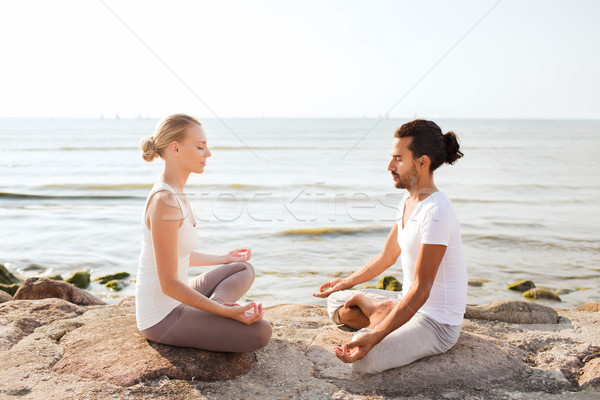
[148,191,262,324]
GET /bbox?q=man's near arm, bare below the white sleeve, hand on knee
[334,244,446,363]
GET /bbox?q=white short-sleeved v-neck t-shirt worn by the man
[396,191,467,325]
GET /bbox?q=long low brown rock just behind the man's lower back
[465,300,558,324]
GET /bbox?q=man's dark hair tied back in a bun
[394,119,463,172]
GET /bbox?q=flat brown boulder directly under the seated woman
[52,314,254,386]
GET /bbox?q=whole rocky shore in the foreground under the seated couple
[0,278,600,399]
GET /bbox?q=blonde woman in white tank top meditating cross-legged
[136,114,271,352]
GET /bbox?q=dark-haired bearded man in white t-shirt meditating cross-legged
[313,120,467,373]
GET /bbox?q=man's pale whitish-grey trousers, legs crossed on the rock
[327,289,461,374]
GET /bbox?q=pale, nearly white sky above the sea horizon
[0,0,600,119]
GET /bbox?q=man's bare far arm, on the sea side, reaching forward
[313,224,400,297]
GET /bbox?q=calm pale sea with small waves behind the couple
[0,118,600,308]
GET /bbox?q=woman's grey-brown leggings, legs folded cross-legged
[141,262,271,353]
